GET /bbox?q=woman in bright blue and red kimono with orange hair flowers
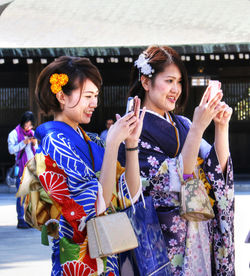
[35,57,144,275]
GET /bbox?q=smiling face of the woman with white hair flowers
[142,64,182,116]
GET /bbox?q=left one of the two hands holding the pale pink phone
[192,86,223,132]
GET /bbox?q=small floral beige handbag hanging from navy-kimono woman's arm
[177,161,214,221]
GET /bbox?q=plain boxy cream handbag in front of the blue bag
[87,212,138,259]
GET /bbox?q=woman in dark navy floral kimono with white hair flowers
[119,46,235,276]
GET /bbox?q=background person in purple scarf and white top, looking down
[8,111,37,229]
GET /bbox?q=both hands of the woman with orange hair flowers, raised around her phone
[106,97,145,146]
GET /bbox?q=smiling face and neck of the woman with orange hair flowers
[55,79,99,129]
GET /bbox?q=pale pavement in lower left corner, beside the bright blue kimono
[0,193,51,276]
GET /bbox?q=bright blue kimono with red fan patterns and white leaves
[35,122,131,276]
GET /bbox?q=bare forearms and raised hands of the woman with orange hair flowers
[100,97,145,206]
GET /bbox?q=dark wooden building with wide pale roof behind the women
[0,0,250,177]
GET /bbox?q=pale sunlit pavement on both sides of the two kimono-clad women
[0,178,250,276]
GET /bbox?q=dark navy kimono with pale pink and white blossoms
[119,112,235,276]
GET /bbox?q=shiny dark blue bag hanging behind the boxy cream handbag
[119,195,171,276]
